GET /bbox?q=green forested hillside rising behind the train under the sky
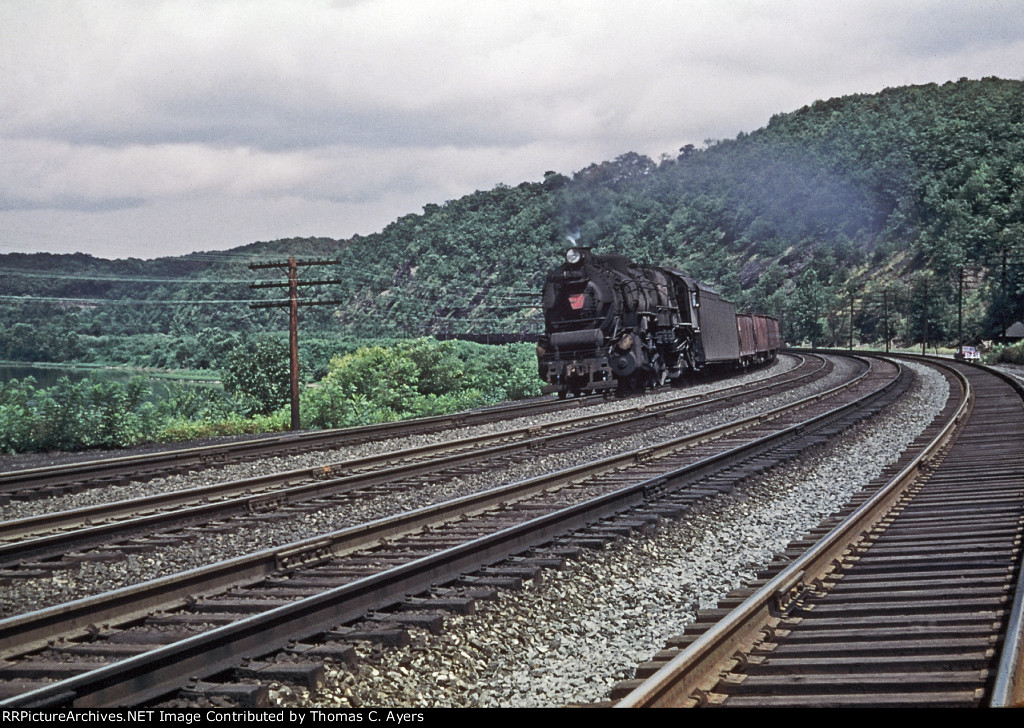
[0,79,1024,360]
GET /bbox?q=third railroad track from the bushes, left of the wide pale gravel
[0,352,904,708]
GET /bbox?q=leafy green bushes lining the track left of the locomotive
[0,338,541,453]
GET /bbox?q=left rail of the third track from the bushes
[0,352,880,657]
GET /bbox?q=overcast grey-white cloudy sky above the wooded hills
[0,0,1024,258]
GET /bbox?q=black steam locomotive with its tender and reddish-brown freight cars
[537,247,781,397]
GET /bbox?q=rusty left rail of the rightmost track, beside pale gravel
[616,358,974,708]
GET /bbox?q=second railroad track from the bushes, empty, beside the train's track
[0,357,831,580]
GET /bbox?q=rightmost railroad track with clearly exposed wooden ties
[613,360,1024,706]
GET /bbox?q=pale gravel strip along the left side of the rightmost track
[274,363,948,708]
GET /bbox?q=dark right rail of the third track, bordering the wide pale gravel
[0,352,900,708]
